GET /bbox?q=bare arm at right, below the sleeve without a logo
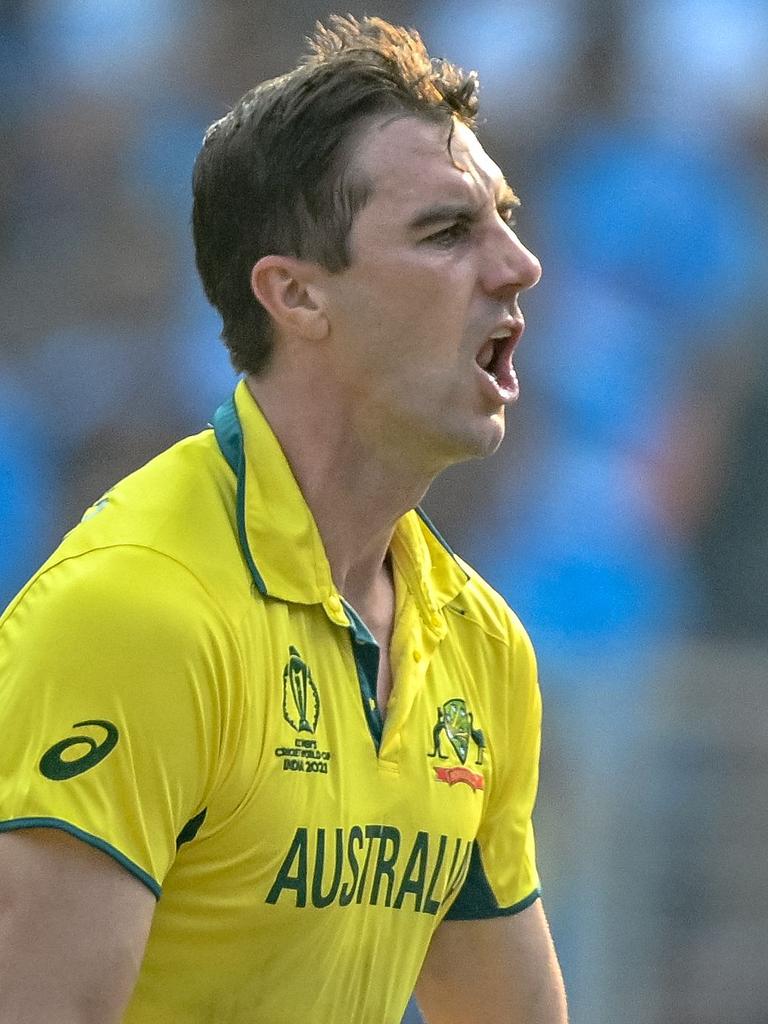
[416,900,567,1024]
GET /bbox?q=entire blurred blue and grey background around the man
[0,0,768,1024]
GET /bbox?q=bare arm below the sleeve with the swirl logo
[0,828,155,1024]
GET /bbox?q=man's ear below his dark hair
[251,255,329,341]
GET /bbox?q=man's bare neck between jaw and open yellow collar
[247,376,433,602]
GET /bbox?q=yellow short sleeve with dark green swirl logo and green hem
[0,546,240,896]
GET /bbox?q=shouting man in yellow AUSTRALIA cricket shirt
[0,18,565,1024]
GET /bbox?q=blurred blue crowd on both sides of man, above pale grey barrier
[0,0,768,1019]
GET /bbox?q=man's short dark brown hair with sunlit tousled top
[193,15,477,374]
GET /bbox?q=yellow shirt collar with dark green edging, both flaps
[213,381,468,615]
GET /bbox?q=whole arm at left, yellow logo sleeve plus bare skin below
[0,548,240,1024]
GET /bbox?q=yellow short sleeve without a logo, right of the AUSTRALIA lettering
[446,615,542,921]
